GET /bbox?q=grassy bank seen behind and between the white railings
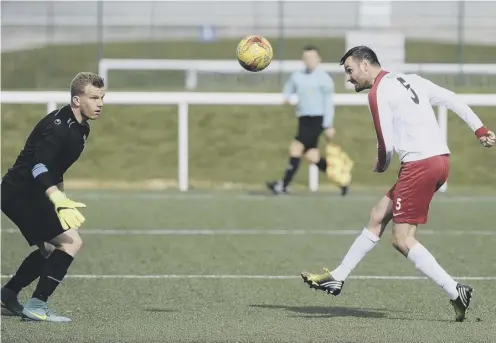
[1,37,496,191]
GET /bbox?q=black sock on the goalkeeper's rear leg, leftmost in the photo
[5,249,45,293]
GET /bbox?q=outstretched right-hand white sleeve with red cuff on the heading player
[417,76,494,144]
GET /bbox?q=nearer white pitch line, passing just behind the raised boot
[1,274,496,281]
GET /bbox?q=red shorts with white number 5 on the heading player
[387,155,450,224]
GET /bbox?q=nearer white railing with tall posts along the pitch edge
[0,91,496,192]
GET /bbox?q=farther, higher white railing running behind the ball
[98,58,496,90]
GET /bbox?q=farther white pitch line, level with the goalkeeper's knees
[0,228,496,236]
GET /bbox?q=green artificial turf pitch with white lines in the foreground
[1,191,496,343]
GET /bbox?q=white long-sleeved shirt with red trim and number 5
[368,71,487,172]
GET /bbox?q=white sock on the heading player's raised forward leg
[331,228,379,281]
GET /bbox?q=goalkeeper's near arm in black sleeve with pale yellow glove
[31,124,86,230]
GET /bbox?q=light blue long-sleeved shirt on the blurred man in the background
[283,67,334,128]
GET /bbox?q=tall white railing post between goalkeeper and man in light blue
[178,102,189,192]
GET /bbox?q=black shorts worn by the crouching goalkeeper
[0,182,65,245]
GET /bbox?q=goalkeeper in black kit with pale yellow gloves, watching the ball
[1,73,105,322]
